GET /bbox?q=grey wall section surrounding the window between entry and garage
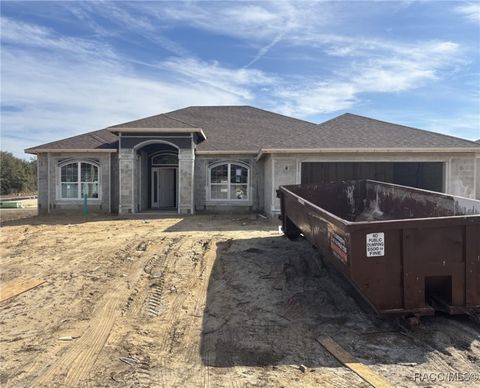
[194,154,264,212]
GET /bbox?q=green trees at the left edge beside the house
[0,151,37,195]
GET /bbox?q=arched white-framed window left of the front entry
[59,161,100,199]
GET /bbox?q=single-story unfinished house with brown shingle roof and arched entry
[26,106,480,216]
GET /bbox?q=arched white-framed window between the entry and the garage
[208,162,250,201]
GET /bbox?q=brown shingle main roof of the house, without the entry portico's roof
[27,106,480,153]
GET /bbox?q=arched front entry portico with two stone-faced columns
[118,134,196,214]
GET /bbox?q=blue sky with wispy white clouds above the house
[1,1,480,157]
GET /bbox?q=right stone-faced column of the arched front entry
[178,149,195,214]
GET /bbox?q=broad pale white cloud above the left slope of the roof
[2,50,250,157]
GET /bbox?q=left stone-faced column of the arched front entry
[118,148,134,214]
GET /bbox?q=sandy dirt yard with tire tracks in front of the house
[0,216,480,387]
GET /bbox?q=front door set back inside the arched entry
[151,167,176,208]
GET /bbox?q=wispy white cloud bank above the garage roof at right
[268,42,463,117]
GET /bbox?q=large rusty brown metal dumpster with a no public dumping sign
[277,180,480,316]
